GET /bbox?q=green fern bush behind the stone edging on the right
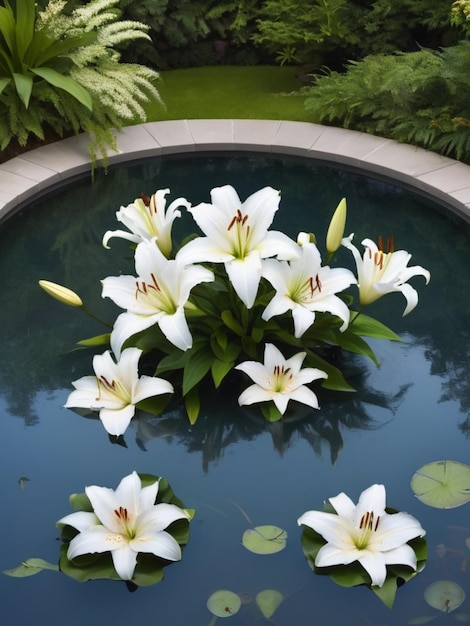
[304,41,470,163]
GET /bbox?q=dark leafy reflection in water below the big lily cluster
[126,360,409,472]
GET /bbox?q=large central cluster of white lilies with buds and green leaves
[40,185,430,436]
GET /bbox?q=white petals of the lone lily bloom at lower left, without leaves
[57,472,190,580]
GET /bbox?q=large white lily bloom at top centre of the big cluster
[176,185,299,309]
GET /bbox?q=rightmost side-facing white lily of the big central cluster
[343,234,431,315]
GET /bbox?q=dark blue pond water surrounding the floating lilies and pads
[0,155,470,626]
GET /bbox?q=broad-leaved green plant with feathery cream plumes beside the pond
[0,0,159,163]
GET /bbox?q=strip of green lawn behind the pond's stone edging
[147,66,309,121]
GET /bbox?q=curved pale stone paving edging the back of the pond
[0,120,470,222]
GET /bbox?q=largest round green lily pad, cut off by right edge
[411,461,470,509]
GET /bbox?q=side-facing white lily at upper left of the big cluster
[103,189,191,258]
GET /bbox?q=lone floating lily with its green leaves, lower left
[57,472,194,586]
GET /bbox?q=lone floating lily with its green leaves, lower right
[298,485,427,607]
